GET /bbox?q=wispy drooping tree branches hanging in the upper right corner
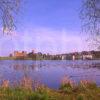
[81,0,100,46]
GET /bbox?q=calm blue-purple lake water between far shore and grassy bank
[0,60,100,88]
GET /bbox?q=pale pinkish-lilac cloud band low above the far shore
[0,28,86,54]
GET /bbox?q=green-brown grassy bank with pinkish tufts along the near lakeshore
[0,78,100,100]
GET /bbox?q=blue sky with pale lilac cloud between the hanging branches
[0,0,90,56]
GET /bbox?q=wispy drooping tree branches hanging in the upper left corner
[0,0,20,34]
